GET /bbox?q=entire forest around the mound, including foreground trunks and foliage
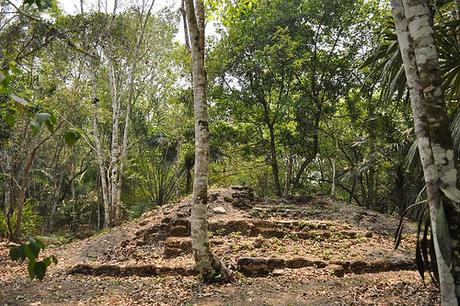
[0,0,460,305]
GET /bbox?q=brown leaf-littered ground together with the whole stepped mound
[0,187,440,305]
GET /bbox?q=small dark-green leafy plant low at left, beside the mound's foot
[10,238,58,280]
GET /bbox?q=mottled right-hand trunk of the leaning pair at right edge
[403,0,460,303]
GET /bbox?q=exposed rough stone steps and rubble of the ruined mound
[70,186,414,277]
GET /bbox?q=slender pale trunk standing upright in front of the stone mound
[186,0,231,280]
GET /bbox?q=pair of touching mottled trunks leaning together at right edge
[391,0,459,305]
